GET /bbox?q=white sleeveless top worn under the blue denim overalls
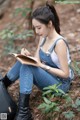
[40,36,74,79]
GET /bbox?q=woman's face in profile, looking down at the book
[32,19,49,37]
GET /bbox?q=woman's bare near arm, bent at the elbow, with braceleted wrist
[40,40,69,78]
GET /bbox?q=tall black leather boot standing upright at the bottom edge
[15,93,33,120]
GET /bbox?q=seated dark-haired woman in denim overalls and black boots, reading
[2,4,72,120]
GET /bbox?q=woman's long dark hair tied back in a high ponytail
[31,3,60,34]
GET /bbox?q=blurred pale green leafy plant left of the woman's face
[0,28,33,54]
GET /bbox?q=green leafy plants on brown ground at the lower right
[38,84,80,120]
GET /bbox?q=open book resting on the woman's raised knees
[10,53,39,66]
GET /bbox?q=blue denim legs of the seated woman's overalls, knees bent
[7,61,70,94]
